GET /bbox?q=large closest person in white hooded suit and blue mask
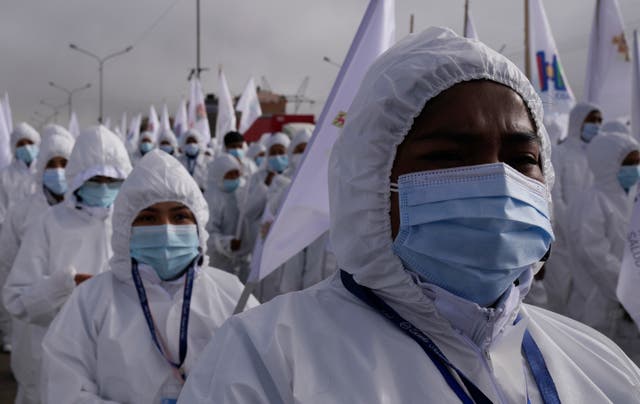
[178,28,640,404]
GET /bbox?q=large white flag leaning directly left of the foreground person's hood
[251,0,395,280]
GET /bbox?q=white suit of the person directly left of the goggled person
[0,125,75,344]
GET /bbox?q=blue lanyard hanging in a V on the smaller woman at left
[131,257,198,381]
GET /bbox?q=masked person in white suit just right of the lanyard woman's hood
[204,153,254,282]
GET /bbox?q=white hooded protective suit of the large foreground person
[179,28,640,404]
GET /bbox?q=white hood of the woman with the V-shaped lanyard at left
[110,150,209,280]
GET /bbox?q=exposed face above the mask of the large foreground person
[391,81,544,239]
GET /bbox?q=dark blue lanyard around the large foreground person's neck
[340,270,560,404]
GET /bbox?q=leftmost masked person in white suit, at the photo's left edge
[0,122,40,225]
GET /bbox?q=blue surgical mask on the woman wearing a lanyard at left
[130,224,200,281]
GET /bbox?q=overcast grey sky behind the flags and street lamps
[0,0,640,126]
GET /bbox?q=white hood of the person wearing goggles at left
[65,126,131,196]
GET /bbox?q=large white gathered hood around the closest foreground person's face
[329,28,554,308]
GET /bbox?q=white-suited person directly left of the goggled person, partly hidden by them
[0,125,74,356]
